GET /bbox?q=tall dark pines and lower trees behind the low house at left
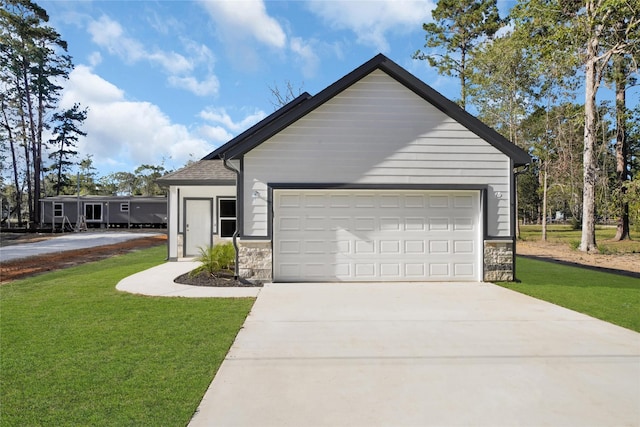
[0,0,168,226]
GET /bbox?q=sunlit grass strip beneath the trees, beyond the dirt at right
[520,225,640,254]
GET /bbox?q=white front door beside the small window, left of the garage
[184,199,213,257]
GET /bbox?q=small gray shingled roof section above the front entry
[156,160,236,186]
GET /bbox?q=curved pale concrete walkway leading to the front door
[116,261,262,298]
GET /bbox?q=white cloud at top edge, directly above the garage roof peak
[310,0,435,52]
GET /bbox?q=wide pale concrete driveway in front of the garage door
[190,283,640,427]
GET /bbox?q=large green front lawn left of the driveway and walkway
[0,246,254,426]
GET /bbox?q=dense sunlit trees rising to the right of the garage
[414,0,640,251]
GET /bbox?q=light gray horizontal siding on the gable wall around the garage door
[243,70,511,237]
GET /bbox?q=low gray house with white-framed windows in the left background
[40,195,167,229]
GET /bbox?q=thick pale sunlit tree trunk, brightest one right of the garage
[579,44,598,252]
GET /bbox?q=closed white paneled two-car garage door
[273,190,481,282]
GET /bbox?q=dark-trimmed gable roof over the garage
[204,54,531,166]
